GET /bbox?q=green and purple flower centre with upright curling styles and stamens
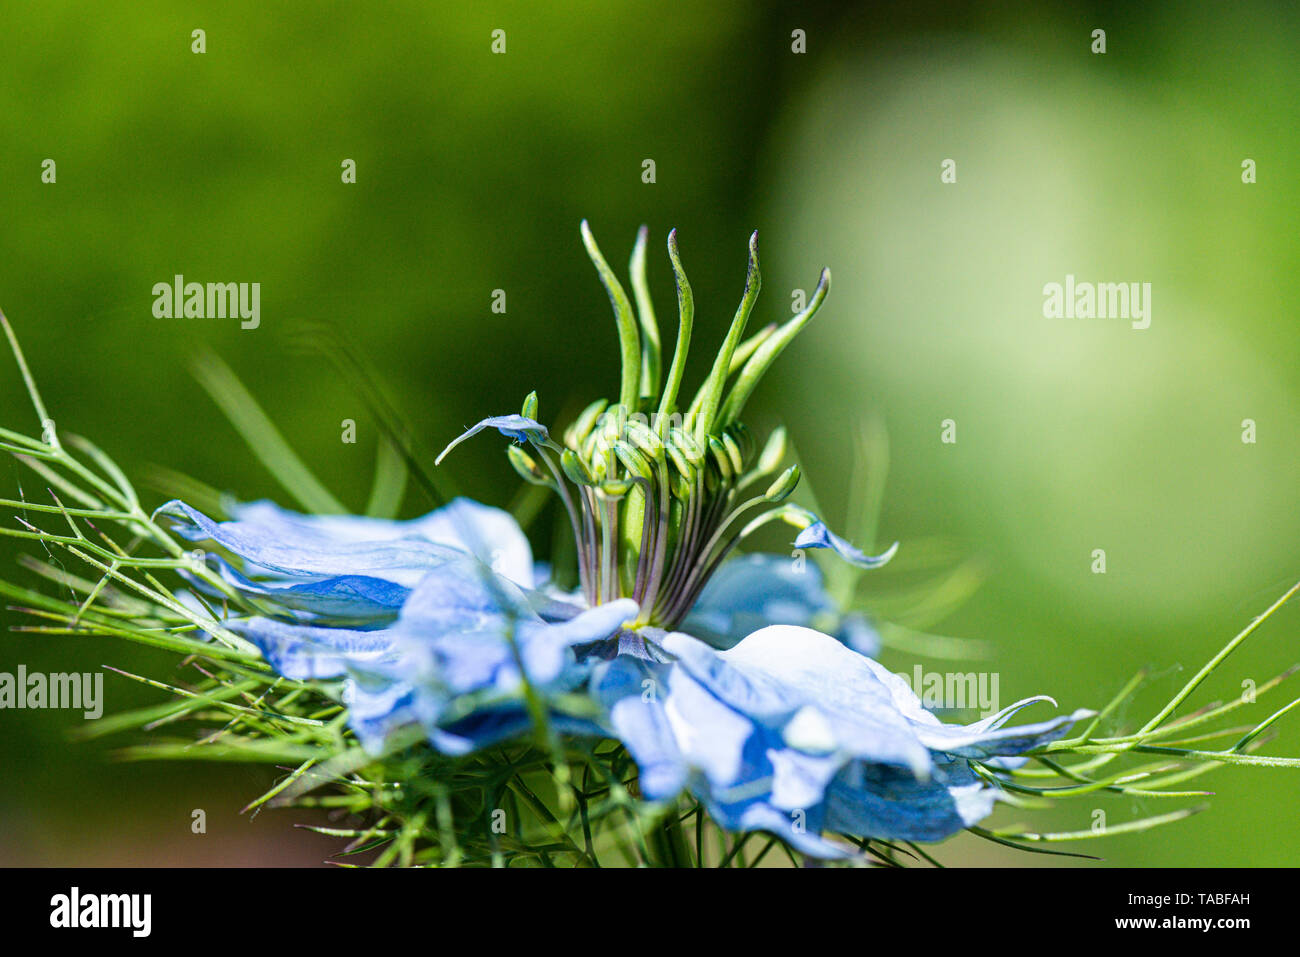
[437,221,832,629]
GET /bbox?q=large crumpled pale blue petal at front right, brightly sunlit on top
[593,625,1087,857]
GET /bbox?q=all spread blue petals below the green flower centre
[160,499,1086,858]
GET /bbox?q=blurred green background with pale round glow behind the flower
[0,0,1300,866]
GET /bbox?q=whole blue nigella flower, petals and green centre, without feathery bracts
[160,222,1087,857]
